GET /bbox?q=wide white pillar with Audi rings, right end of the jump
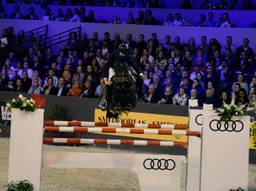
[200,110,250,191]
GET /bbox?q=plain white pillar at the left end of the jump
[8,109,44,191]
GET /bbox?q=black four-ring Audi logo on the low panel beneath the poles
[143,158,176,170]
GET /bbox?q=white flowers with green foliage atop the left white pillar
[6,94,35,112]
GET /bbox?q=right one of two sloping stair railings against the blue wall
[47,26,82,47]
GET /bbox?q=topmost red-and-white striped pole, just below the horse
[45,121,187,129]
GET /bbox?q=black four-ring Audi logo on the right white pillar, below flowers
[209,119,244,132]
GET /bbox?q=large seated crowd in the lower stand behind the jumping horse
[0,27,256,107]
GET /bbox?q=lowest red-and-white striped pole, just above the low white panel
[43,137,187,148]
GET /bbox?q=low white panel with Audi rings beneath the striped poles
[44,152,185,191]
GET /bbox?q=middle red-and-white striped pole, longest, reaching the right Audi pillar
[44,126,201,137]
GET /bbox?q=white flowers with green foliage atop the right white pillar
[217,103,246,121]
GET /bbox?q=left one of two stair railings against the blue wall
[25,25,48,45]
